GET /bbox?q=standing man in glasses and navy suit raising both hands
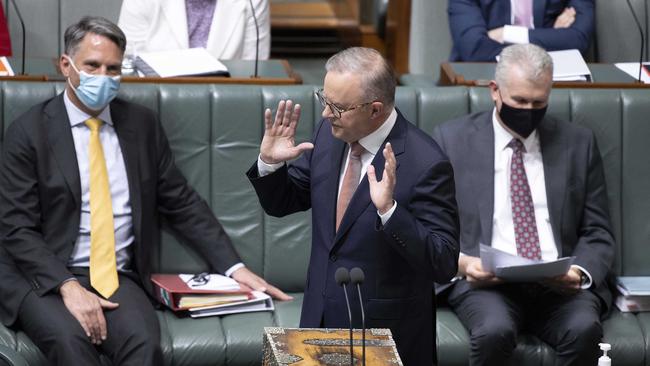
[248,48,458,365]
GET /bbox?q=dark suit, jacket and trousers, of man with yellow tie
[0,94,241,365]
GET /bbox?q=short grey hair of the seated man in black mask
[494,44,553,86]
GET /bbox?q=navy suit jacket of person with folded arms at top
[447,0,594,62]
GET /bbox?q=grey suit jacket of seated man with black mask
[434,111,614,309]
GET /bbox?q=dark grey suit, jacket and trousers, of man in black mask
[434,111,614,364]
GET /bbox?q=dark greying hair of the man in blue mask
[63,16,126,56]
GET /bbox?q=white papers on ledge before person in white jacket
[135,47,230,78]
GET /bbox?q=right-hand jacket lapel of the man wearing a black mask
[537,119,569,256]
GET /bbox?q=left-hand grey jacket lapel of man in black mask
[468,112,494,245]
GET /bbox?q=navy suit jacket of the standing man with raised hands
[248,114,459,365]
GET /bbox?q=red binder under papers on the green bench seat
[151,274,252,311]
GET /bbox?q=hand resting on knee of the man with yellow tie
[59,281,119,345]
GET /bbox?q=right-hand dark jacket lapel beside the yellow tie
[111,102,142,246]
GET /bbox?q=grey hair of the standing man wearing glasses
[325,47,397,107]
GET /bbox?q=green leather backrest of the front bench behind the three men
[0,82,650,291]
